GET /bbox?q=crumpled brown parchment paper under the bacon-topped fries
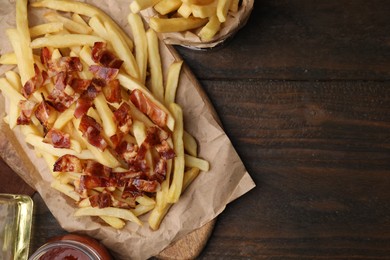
[0,0,255,259]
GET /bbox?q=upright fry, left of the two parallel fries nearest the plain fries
[127,13,148,84]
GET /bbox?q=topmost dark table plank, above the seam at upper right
[178,0,390,80]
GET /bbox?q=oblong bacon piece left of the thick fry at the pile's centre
[79,115,107,151]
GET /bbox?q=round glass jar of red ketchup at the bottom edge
[29,234,112,260]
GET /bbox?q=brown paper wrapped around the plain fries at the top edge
[141,0,254,49]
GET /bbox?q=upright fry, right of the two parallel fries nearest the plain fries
[146,29,164,102]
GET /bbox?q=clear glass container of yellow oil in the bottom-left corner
[0,194,33,260]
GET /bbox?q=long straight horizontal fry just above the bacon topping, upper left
[31,34,105,49]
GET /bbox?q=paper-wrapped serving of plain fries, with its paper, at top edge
[130,0,254,49]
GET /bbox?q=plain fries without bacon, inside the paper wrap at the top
[130,0,240,42]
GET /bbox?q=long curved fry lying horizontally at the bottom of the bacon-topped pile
[74,207,142,226]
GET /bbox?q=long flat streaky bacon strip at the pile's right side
[130,89,168,127]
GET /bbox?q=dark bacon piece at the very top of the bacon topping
[92,42,123,69]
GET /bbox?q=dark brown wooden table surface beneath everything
[1,0,390,259]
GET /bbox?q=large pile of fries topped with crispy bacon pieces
[0,0,209,230]
